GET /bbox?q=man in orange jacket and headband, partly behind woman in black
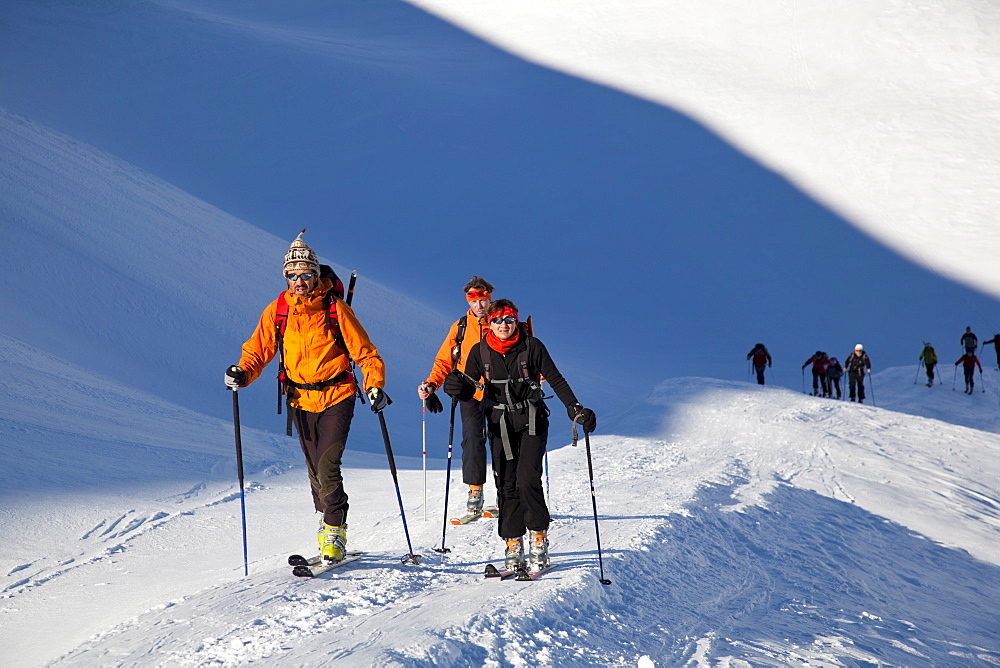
[417,276,493,515]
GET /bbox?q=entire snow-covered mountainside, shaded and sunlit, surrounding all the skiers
[0,0,1000,666]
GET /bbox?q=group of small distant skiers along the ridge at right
[747,327,1000,404]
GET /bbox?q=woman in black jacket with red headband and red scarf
[444,299,597,572]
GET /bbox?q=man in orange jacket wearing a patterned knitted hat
[226,230,391,561]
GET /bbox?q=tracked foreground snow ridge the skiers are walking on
[4,372,1000,665]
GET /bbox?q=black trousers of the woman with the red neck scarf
[489,416,551,538]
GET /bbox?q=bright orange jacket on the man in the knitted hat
[240,278,385,413]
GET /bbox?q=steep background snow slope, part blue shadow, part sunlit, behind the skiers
[0,0,1000,402]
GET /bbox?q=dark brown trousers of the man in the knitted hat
[295,396,354,526]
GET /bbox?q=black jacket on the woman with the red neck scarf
[465,334,579,431]
